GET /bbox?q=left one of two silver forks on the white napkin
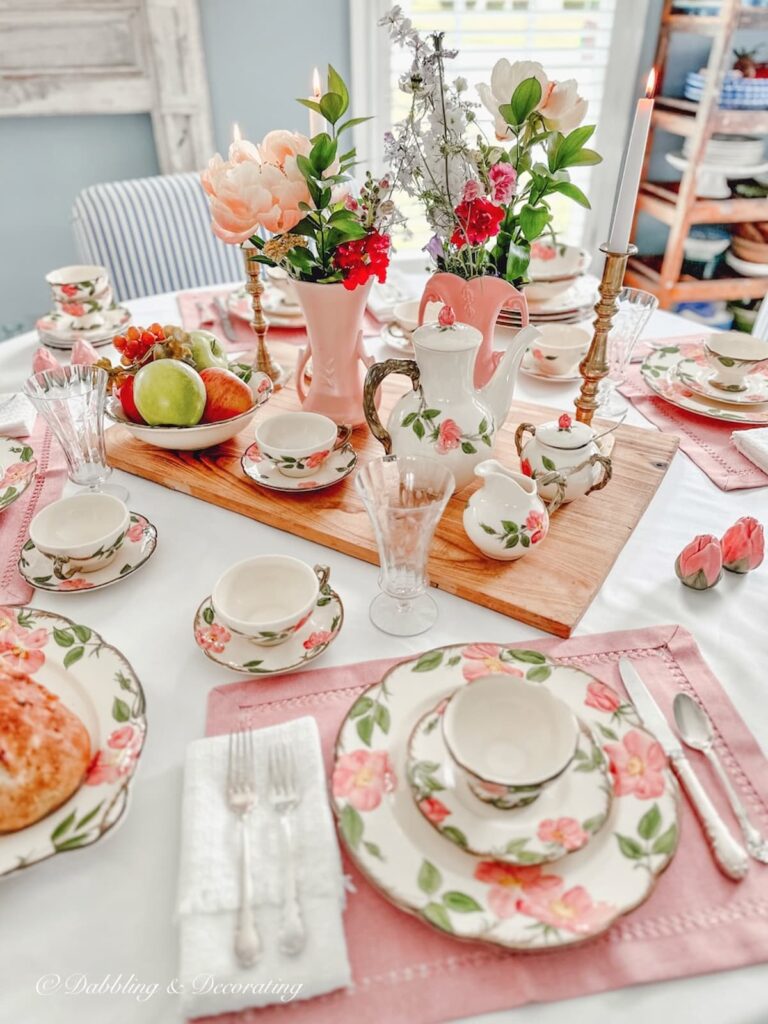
[226,729,261,967]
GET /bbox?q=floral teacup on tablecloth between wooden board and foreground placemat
[211,555,331,647]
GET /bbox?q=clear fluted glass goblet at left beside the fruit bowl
[25,366,128,501]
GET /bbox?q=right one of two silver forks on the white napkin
[269,740,306,956]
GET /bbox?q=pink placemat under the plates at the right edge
[620,333,768,490]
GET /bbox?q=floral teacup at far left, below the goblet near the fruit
[30,494,130,580]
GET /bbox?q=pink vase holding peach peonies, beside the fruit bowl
[294,281,374,426]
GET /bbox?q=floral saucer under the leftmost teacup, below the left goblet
[18,512,158,594]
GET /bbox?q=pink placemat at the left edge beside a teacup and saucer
[0,416,67,604]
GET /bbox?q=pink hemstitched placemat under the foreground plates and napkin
[204,626,768,1024]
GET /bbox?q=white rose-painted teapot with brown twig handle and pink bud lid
[364,306,540,490]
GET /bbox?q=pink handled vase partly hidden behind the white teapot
[419,273,528,387]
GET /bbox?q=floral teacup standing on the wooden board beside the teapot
[255,413,352,476]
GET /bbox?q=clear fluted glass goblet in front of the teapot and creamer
[354,455,455,637]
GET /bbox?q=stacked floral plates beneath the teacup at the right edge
[640,342,768,426]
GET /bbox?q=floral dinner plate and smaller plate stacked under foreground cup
[332,643,679,950]
